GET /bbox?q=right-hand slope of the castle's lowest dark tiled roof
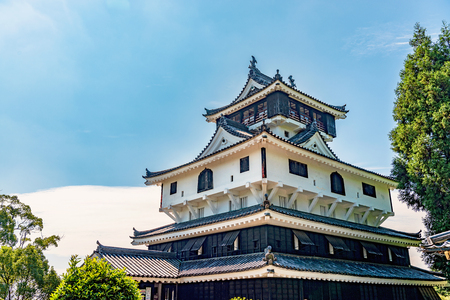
[274,253,442,281]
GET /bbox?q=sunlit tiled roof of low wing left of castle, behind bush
[94,243,180,278]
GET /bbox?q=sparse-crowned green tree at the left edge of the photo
[0,195,60,300]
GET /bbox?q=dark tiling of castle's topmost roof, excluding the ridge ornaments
[203,68,348,117]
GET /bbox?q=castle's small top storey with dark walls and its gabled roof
[204,56,348,141]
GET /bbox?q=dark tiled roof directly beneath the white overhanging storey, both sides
[131,205,419,240]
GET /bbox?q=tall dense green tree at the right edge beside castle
[390,22,450,279]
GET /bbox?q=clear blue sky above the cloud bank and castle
[0,0,450,194]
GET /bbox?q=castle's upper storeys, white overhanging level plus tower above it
[143,58,397,227]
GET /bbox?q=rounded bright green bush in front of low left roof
[50,256,141,300]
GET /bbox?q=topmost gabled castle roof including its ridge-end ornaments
[203,60,348,117]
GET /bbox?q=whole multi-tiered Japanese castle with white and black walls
[94,57,446,300]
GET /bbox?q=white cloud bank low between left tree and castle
[18,186,172,273]
